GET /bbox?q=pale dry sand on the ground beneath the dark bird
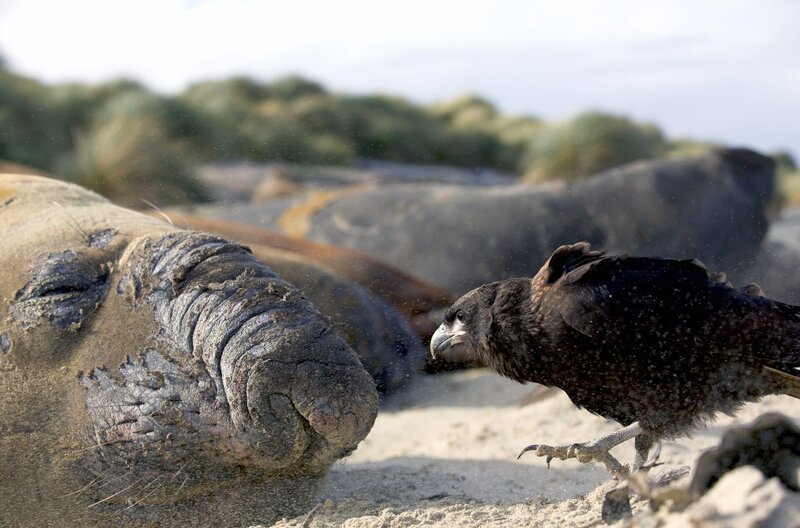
[260,369,800,528]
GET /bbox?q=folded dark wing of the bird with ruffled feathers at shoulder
[540,245,800,368]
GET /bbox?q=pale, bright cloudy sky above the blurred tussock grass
[0,0,800,158]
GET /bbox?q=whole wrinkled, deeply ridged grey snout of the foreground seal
[139,233,378,471]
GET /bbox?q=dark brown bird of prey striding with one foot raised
[431,242,800,474]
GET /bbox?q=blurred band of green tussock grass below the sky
[0,63,768,205]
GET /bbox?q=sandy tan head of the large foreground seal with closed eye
[0,175,378,526]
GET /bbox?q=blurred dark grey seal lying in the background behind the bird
[198,149,774,292]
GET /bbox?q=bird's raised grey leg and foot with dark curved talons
[517,422,652,475]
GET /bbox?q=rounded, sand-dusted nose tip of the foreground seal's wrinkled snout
[223,328,377,467]
